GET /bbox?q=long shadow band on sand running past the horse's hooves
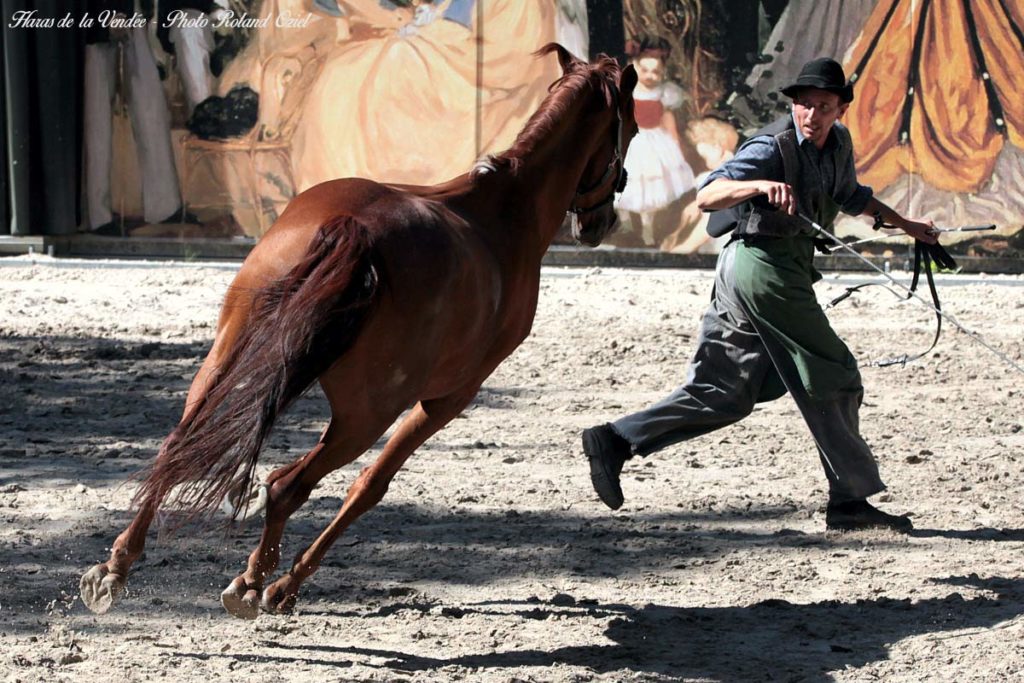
[0,493,901,631]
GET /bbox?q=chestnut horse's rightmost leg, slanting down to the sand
[262,385,479,612]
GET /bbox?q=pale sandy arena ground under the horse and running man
[0,253,1024,683]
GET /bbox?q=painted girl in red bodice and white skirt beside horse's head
[615,38,694,247]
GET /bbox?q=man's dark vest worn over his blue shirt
[708,114,853,238]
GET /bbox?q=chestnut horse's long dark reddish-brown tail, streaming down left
[134,216,380,523]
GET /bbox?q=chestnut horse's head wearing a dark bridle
[552,45,638,247]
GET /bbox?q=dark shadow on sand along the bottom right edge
[175,574,1024,681]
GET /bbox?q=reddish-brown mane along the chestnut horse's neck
[471,43,621,177]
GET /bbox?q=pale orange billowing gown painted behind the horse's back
[292,0,558,190]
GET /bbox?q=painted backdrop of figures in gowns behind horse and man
[81,0,1024,255]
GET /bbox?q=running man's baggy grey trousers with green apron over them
[612,237,885,502]
